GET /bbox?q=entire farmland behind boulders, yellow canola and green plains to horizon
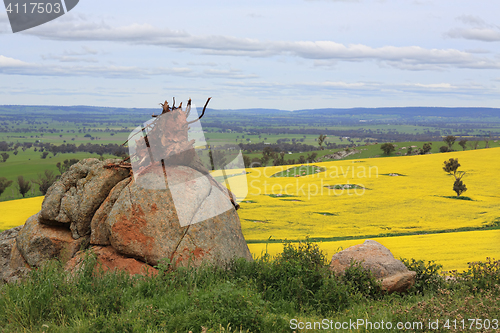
[0,106,500,269]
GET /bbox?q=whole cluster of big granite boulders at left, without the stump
[0,159,252,282]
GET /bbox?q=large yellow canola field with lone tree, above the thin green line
[234,148,500,240]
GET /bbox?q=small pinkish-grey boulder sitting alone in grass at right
[330,240,417,293]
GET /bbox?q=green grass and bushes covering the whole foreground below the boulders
[0,240,500,333]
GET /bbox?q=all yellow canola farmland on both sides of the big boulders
[0,148,500,270]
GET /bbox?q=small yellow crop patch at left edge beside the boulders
[0,197,44,230]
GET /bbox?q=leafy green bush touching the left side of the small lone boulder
[236,239,358,315]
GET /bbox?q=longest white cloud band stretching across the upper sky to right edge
[24,19,500,70]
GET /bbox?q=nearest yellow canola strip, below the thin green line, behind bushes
[248,230,500,271]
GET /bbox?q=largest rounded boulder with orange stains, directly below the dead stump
[92,166,252,265]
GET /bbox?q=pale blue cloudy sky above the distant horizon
[0,0,500,110]
